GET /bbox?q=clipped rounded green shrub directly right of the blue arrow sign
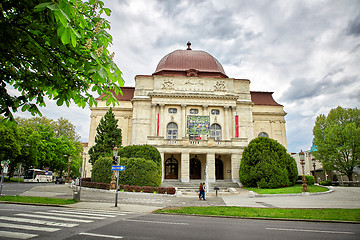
[119,158,161,188]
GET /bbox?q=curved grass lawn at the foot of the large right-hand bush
[244,184,329,194]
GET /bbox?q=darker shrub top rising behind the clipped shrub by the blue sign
[119,145,161,167]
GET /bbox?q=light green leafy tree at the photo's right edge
[313,107,360,181]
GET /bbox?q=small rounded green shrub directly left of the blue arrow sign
[91,157,113,183]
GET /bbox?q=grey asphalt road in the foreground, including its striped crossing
[0,204,360,240]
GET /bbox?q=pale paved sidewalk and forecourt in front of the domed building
[18,185,360,212]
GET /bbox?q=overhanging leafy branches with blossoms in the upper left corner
[0,0,123,120]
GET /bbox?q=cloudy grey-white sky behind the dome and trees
[14,0,360,152]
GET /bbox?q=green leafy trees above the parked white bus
[0,115,82,177]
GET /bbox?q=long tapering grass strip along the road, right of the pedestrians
[156,206,360,222]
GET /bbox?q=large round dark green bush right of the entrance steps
[239,137,298,188]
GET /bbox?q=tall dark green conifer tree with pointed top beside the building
[89,108,122,164]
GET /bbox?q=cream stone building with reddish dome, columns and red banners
[86,44,287,182]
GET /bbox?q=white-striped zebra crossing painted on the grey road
[0,209,127,240]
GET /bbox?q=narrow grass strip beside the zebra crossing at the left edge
[0,196,76,205]
